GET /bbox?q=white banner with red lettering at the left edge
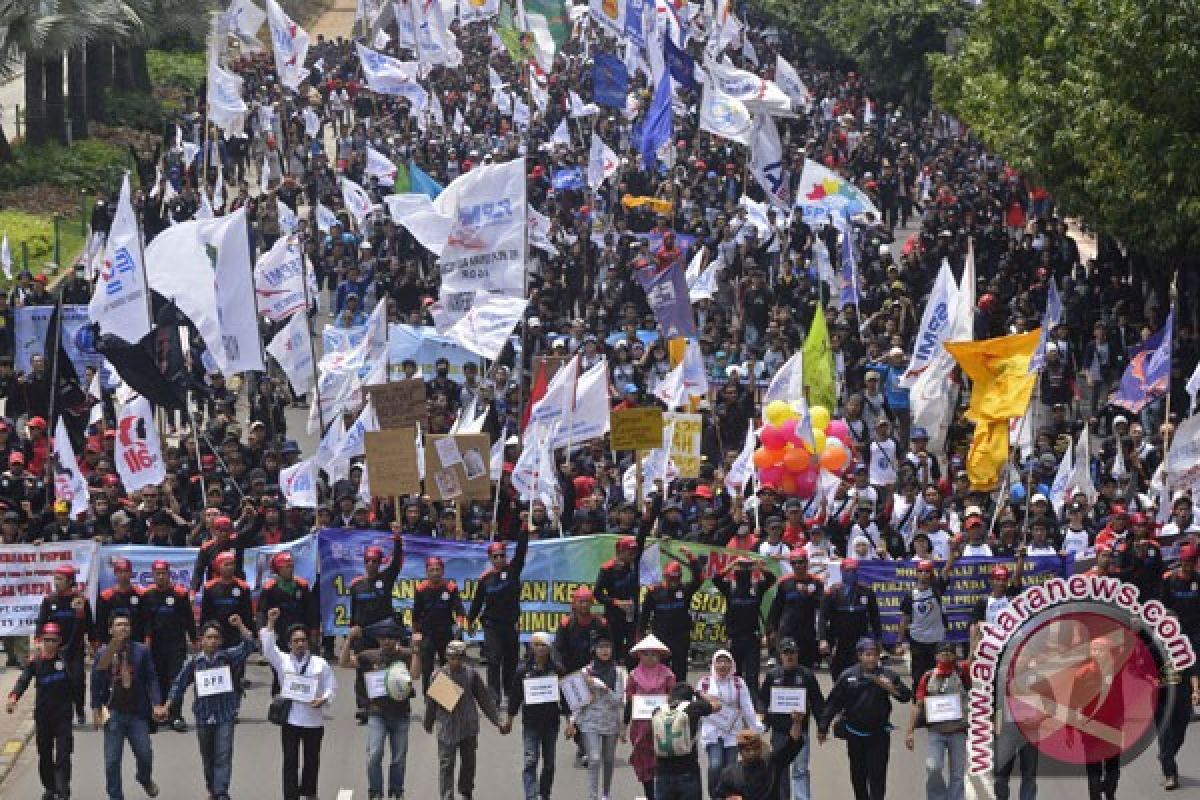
[0,542,99,636]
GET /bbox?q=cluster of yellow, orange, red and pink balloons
[754,401,853,499]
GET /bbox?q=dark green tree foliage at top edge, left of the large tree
[757,0,971,106]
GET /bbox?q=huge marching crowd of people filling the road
[0,0,1200,800]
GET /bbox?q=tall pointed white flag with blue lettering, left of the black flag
[90,174,150,344]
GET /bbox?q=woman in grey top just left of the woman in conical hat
[563,634,628,800]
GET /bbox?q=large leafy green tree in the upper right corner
[934,0,1200,260]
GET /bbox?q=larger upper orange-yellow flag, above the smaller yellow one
[946,330,1040,422]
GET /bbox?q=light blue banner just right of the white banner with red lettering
[95,534,317,597]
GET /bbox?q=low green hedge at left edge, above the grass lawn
[0,139,130,191]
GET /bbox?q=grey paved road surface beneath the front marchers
[0,652,1200,800]
